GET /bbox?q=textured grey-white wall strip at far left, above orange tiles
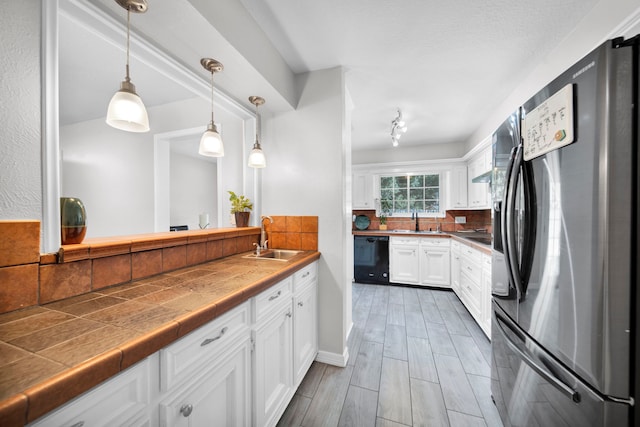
[0,0,42,220]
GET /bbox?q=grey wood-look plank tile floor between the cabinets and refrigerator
[278,283,502,427]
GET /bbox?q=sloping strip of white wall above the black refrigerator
[467,0,640,150]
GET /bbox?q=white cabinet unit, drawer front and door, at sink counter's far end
[293,262,318,387]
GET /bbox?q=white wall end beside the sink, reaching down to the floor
[262,68,351,364]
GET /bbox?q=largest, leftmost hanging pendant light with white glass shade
[107,0,149,132]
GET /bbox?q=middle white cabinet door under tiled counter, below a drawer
[254,303,293,426]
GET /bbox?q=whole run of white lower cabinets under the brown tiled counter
[30,262,318,427]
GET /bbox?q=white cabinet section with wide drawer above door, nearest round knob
[159,303,251,427]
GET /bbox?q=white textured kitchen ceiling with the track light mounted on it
[240,0,597,151]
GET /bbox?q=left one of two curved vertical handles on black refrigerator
[503,144,524,300]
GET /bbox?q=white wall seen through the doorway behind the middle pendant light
[169,152,217,230]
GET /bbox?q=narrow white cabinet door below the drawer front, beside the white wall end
[293,282,318,388]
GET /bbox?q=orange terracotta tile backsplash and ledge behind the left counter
[0,221,318,318]
